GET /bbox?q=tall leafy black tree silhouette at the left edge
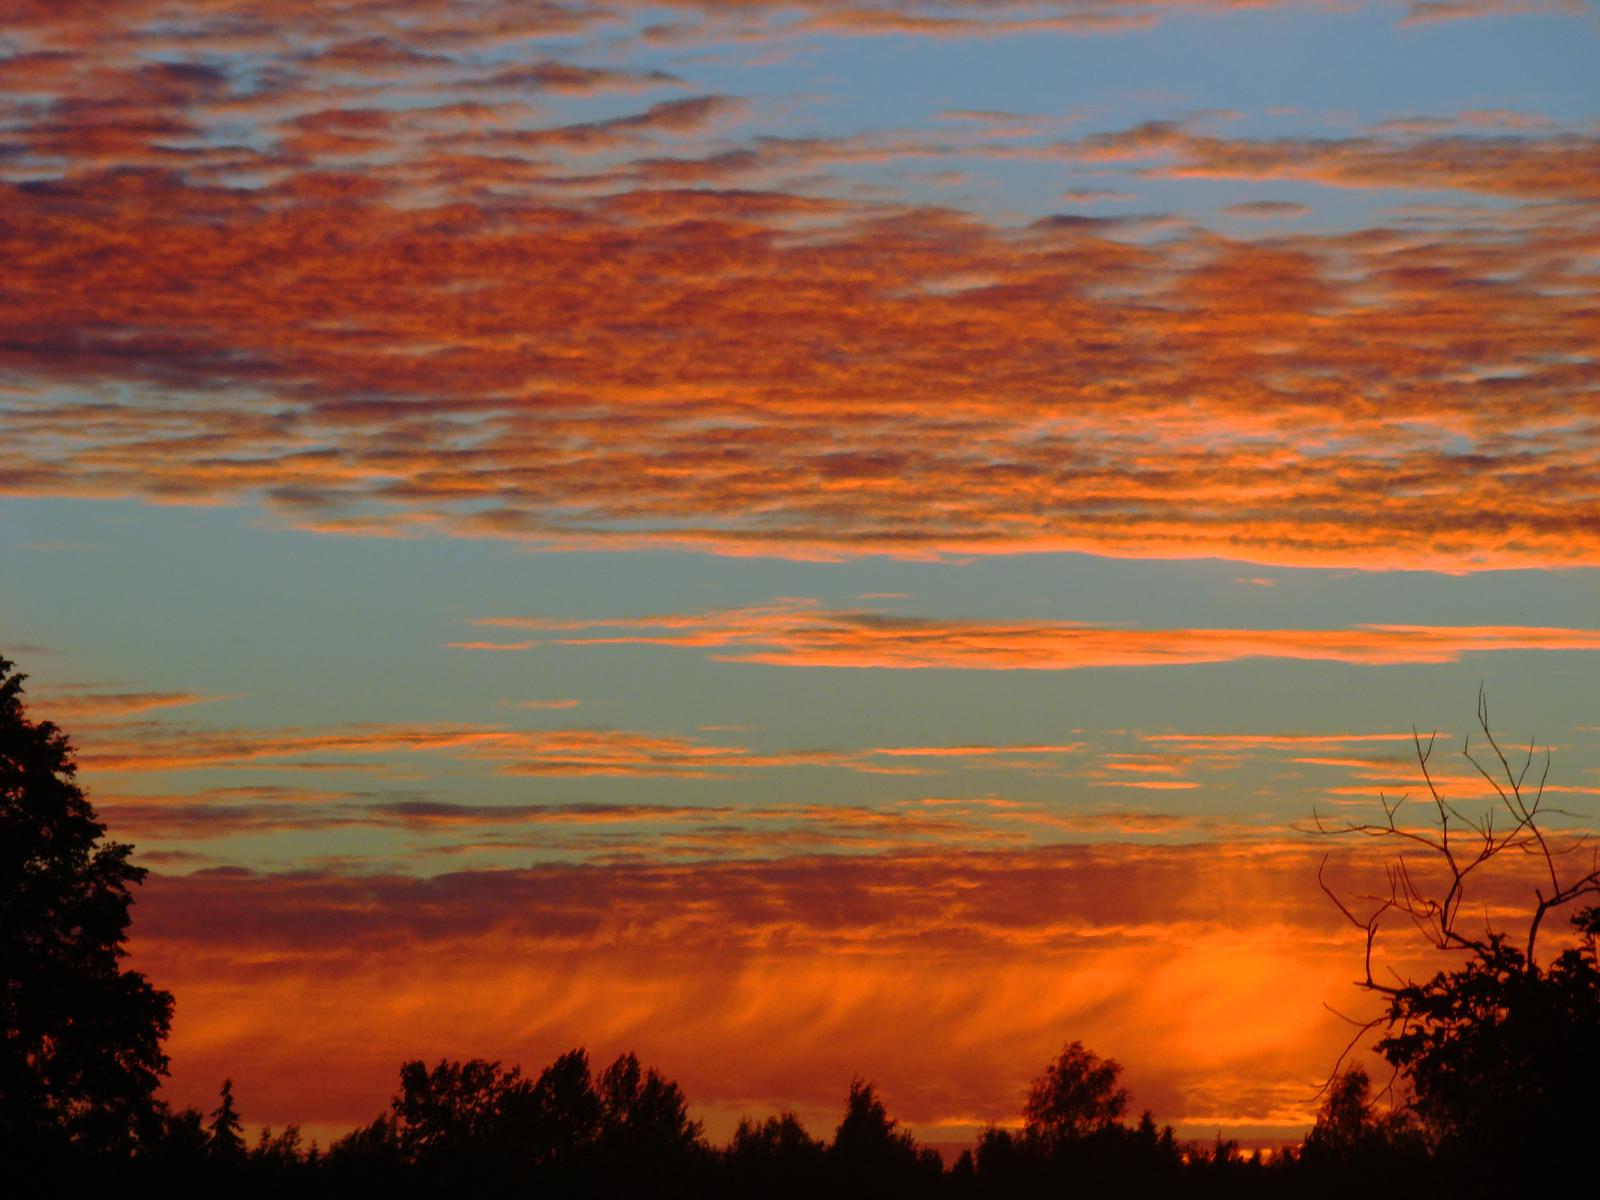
[0,658,173,1150]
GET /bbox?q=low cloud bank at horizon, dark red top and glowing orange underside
[124,843,1574,1136]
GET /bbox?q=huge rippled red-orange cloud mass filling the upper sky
[0,0,1600,570]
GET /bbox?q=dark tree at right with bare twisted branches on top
[1317,688,1600,1160]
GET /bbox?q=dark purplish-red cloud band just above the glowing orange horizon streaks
[138,843,1342,957]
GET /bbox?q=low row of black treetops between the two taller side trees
[15,1030,1587,1200]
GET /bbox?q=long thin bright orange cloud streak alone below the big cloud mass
[464,605,1600,670]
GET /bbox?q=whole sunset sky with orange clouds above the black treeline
[0,0,1600,1144]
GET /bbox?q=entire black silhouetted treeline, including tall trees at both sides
[0,658,1600,1200]
